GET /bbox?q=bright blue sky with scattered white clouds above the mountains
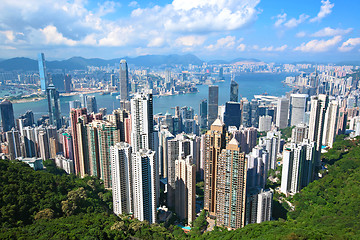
[0,0,360,62]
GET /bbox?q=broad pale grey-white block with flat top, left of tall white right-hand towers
[290,94,308,126]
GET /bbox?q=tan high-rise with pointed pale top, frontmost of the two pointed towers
[216,138,246,229]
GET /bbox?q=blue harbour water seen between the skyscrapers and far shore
[13,73,291,119]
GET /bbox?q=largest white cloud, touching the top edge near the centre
[160,0,260,32]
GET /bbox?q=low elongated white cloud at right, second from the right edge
[294,36,342,52]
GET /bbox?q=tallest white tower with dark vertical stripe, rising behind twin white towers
[131,93,155,152]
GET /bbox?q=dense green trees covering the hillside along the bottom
[0,136,360,240]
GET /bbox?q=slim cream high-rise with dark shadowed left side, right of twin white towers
[175,155,196,224]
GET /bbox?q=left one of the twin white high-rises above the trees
[110,142,134,215]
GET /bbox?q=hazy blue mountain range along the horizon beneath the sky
[0,54,260,71]
